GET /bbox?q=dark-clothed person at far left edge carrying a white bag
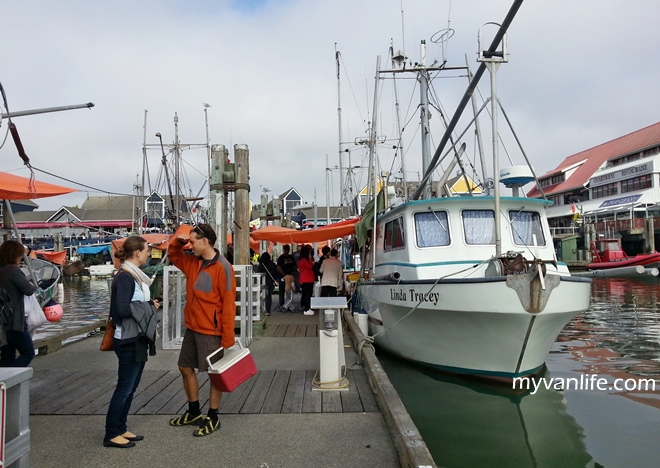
[0,240,36,367]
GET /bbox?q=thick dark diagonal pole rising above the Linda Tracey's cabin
[411,0,523,200]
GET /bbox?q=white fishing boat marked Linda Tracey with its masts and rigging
[356,5,591,380]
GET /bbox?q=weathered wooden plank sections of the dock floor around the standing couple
[30,324,379,415]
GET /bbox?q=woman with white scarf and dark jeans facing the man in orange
[103,236,159,448]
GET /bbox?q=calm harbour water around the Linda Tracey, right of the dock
[379,279,660,468]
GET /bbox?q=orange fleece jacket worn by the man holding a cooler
[167,241,236,348]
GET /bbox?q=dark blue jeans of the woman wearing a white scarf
[105,339,145,440]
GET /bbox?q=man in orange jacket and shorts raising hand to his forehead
[167,224,236,437]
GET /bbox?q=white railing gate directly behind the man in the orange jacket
[162,265,263,349]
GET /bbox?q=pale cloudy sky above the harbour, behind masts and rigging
[0,0,660,213]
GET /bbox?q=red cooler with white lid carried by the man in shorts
[206,340,257,392]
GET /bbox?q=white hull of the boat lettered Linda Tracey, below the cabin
[358,277,590,378]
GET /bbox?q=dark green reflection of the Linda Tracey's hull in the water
[379,353,597,467]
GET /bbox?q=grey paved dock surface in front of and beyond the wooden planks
[30,296,400,468]
